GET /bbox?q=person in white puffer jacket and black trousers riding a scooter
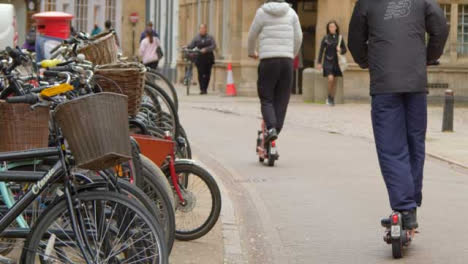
[248,0,302,142]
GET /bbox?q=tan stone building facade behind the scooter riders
[179,0,468,100]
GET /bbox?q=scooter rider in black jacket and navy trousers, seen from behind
[348,0,448,232]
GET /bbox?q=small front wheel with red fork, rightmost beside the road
[165,161,221,241]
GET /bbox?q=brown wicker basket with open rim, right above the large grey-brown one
[95,63,146,116]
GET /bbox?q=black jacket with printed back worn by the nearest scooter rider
[348,0,448,94]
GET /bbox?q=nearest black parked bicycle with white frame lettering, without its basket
[0,70,167,263]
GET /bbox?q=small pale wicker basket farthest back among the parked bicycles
[78,32,118,65]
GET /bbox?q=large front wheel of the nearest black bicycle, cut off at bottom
[21,191,168,264]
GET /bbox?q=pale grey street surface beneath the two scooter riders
[173,89,468,264]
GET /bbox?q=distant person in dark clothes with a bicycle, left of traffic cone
[187,24,216,94]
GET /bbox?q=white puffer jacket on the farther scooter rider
[248,2,302,59]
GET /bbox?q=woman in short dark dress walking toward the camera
[317,20,347,106]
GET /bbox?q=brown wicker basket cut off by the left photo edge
[0,101,50,152]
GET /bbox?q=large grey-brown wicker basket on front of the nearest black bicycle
[54,93,132,170]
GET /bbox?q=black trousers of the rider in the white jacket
[257,58,294,133]
